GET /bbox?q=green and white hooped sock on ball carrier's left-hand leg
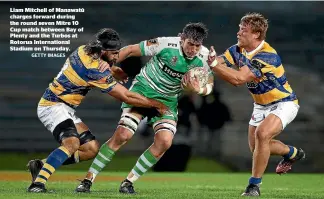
[87,143,115,182]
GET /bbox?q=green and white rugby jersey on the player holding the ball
[136,37,211,97]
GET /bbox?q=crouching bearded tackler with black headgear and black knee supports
[28,28,168,192]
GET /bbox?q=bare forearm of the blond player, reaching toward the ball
[212,64,245,86]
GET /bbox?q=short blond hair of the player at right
[240,12,269,40]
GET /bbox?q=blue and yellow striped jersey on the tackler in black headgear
[39,46,117,108]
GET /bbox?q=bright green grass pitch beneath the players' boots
[0,171,324,199]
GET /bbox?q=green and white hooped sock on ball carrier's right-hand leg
[127,149,159,183]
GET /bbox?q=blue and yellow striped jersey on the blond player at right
[222,41,298,105]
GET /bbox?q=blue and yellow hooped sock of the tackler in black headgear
[35,146,70,184]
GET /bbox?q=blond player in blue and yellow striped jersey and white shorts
[208,13,305,196]
